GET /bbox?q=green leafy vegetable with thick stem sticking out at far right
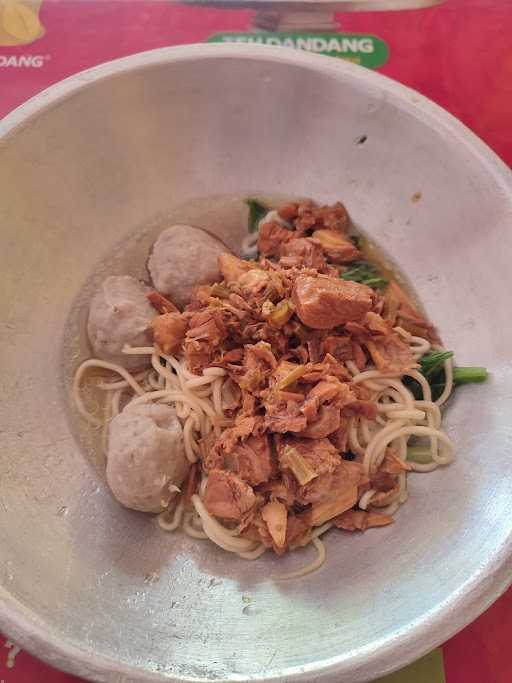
[404,351,487,401]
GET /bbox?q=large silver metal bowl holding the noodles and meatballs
[0,45,512,683]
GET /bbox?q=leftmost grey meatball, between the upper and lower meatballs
[87,275,156,369]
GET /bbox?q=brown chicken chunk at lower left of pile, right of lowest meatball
[203,470,256,522]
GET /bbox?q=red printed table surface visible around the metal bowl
[0,0,512,683]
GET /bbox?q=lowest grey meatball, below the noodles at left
[107,404,189,512]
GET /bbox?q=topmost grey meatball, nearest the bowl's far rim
[148,225,228,308]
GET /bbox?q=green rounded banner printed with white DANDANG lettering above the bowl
[208,32,389,69]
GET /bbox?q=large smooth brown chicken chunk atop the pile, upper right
[292,275,374,330]
